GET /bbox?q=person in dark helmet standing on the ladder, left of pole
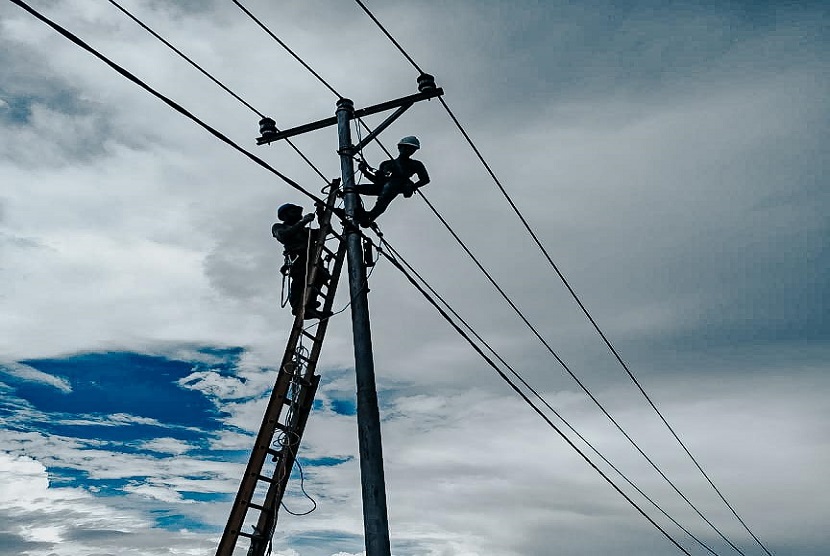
[271,203,331,319]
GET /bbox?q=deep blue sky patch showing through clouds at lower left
[0,348,249,508]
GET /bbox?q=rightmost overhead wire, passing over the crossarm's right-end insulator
[355,0,772,556]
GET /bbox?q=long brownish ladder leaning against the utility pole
[216,188,346,556]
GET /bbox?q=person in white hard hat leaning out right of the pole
[357,135,429,227]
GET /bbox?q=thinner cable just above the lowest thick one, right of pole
[380,237,717,556]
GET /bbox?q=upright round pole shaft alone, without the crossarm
[337,98,391,556]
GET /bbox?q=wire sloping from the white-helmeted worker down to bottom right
[418,191,746,556]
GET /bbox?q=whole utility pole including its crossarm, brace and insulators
[257,74,444,556]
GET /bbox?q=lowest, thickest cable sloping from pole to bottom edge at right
[370,238,691,556]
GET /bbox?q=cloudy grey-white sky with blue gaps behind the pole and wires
[0,0,830,556]
